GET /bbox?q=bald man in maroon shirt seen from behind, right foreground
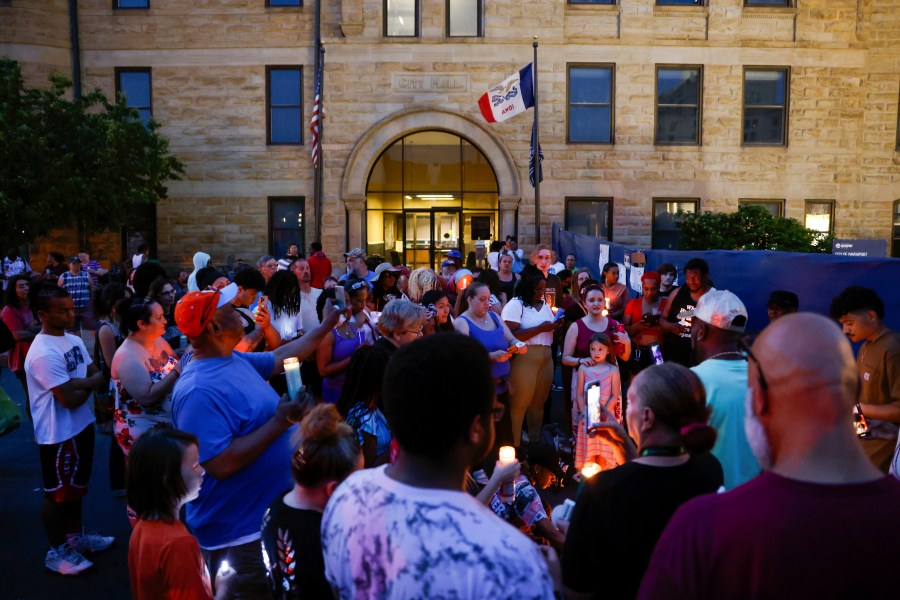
[638,313,900,600]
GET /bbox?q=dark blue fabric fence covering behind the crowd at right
[552,223,900,333]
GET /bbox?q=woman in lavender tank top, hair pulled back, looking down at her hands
[454,281,519,447]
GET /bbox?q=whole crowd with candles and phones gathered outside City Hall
[0,236,900,600]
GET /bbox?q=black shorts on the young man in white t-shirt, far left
[38,423,94,502]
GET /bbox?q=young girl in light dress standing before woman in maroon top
[572,333,622,470]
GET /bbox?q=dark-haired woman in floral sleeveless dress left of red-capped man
[110,301,181,456]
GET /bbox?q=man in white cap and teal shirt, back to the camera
[680,290,759,490]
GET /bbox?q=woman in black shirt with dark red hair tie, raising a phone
[562,363,724,598]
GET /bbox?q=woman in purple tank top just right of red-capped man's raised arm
[316,279,372,404]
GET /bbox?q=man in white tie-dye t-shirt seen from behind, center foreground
[322,335,553,599]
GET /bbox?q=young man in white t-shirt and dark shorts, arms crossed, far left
[25,285,115,575]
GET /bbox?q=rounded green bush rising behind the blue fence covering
[676,205,832,253]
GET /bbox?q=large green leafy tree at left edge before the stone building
[0,58,184,247]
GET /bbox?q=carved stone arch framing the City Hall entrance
[341,107,521,248]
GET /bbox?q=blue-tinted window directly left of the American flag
[266,67,303,145]
